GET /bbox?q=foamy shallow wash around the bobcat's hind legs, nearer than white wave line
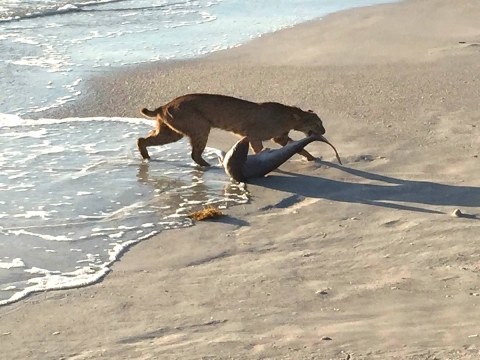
[0,117,248,304]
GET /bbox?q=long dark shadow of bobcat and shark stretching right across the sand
[250,161,480,220]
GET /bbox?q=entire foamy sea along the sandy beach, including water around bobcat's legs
[0,0,396,305]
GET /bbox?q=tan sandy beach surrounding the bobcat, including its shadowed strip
[0,0,480,360]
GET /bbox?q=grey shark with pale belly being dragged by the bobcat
[220,134,341,182]
